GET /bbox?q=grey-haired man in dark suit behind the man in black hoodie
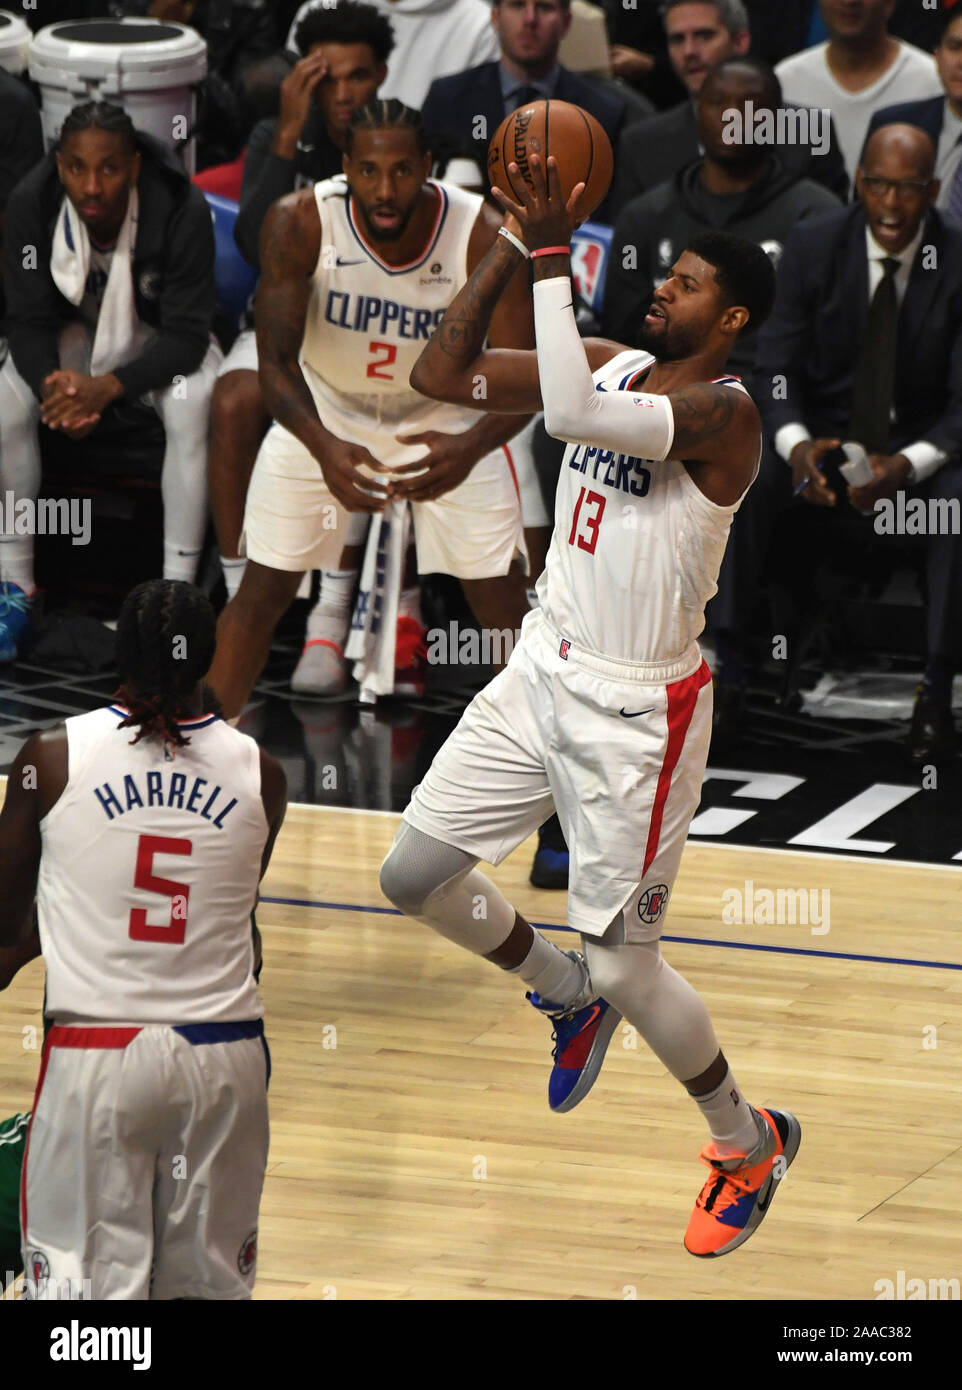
[609,0,848,215]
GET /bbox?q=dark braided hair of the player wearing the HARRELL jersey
[114,580,217,748]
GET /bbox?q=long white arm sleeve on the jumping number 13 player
[534,275,674,459]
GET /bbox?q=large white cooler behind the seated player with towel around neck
[29,19,207,174]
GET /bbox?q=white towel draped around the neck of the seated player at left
[50,188,143,377]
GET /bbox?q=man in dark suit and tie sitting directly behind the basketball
[421,0,626,222]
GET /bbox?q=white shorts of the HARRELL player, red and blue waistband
[21,1020,270,1300]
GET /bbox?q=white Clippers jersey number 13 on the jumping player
[538,350,760,664]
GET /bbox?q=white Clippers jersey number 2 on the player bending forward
[300,174,492,434]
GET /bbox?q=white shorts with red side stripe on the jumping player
[405,609,712,941]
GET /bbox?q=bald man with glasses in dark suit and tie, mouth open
[756,125,962,763]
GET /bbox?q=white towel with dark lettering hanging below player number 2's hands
[345,499,410,705]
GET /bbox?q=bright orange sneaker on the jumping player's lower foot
[685,1111,802,1258]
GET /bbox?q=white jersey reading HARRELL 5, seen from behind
[38,706,268,1024]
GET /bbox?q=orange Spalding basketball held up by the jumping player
[488,101,614,217]
